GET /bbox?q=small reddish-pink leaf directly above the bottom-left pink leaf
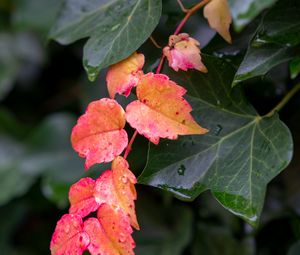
[69,178,99,218]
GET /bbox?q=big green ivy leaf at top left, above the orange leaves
[50,0,161,81]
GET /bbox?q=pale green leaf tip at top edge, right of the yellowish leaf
[229,0,277,31]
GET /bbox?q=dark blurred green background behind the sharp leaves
[0,0,300,255]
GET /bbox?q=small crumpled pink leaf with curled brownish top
[163,33,207,73]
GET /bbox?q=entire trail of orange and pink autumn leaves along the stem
[50,0,230,255]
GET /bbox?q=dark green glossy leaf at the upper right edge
[233,0,300,85]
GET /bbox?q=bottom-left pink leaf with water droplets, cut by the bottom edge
[50,214,90,255]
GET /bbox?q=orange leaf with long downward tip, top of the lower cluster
[95,157,139,229]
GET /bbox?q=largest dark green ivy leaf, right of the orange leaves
[139,57,293,225]
